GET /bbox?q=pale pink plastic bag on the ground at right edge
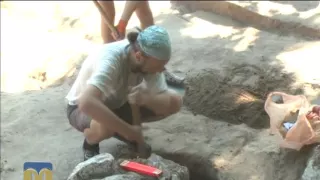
[264,92,320,150]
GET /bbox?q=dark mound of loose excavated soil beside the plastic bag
[184,64,303,128]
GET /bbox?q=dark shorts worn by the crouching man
[67,103,155,132]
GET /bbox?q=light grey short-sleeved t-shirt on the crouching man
[66,40,168,109]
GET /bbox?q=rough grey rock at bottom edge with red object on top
[68,153,189,180]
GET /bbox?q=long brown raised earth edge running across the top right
[171,1,320,39]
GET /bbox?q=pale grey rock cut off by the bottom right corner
[302,145,320,180]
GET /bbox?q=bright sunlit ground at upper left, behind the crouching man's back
[1,1,170,92]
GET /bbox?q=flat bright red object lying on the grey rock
[120,160,162,177]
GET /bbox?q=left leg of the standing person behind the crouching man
[99,1,115,43]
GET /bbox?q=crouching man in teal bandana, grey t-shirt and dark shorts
[66,25,182,160]
